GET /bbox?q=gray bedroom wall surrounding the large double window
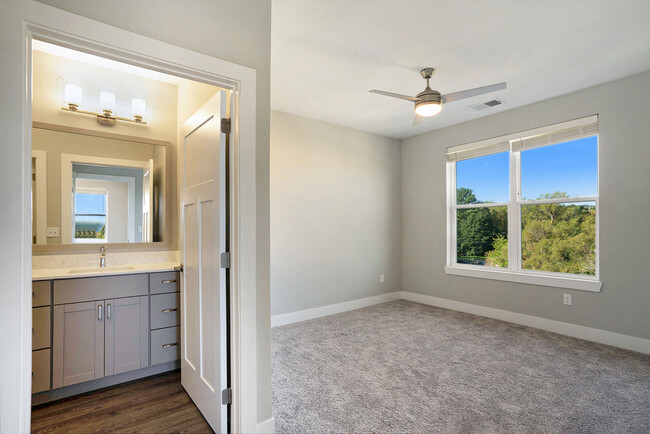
[402,72,650,338]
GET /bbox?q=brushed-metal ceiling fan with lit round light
[370,68,506,126]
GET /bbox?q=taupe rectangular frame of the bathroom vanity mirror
[30,121,173,256]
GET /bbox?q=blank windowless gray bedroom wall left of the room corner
[271,111,400,315]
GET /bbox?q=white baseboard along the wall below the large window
[400,291,650,354]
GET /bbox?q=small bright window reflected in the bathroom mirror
[74,189,108,243]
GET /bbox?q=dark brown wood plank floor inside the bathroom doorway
[32,371,212,433]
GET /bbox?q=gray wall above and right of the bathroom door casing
[26,0,271,421]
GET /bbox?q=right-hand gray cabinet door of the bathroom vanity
[104,296,149,375]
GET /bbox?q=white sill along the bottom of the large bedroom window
[445,265,602,292]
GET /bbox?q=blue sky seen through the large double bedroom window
[456,136,598,202]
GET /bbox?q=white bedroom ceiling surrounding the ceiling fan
[271,0,650,139]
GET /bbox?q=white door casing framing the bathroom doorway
[6,2,257,432]
